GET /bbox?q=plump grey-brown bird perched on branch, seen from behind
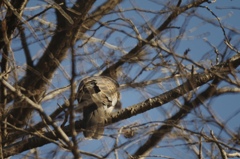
[76,76,121,139]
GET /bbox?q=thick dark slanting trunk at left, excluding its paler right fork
[8,0,95,127]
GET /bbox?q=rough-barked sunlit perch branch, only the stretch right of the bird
[108,52,240,123]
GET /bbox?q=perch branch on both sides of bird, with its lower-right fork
[4,51,240,157]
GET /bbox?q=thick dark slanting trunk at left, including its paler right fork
[8,0,124,127]
